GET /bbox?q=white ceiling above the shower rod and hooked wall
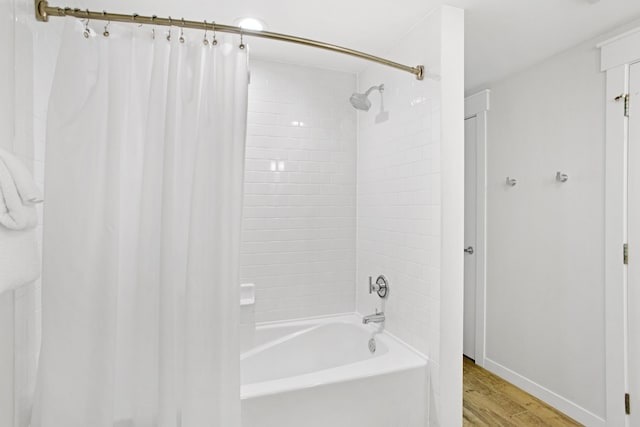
[61,0,640,91]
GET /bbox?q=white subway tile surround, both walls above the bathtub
[241,55,440,360]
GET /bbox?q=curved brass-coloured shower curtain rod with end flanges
[34,0,424,80]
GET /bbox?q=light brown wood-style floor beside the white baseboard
[463,357,582,427]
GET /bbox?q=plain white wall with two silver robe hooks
[486,42,604,425]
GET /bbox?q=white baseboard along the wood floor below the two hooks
[484,357,606,427]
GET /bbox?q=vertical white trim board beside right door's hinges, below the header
[604,65,629,427]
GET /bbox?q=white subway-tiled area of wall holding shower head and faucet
[356,67,440,363]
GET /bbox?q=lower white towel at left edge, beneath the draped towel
[0,227,40,294]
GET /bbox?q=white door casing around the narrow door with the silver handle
[460,89,491,367]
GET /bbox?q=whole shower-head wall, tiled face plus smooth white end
[356,7,464,426]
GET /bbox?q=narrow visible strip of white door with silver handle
[462,117,478,360]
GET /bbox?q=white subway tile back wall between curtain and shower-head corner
[240,60,357,322]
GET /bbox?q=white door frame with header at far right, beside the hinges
[597,28,640,426]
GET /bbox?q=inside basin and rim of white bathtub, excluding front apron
[240,313,427,397]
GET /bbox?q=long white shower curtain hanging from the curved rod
[32,20,248,427]
